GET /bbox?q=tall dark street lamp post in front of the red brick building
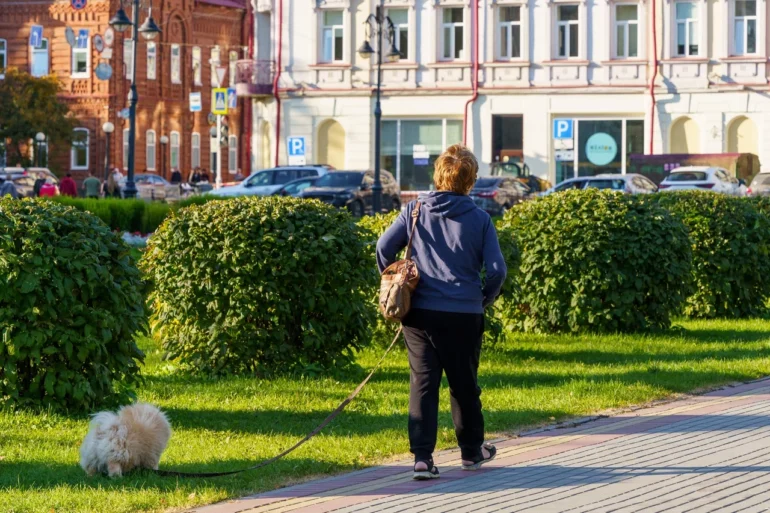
[110,0,160,198]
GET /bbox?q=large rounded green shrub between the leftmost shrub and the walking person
[142,197,374,374]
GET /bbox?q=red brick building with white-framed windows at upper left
[0,0,249,181]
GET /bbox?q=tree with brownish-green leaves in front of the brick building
[0,68,75,166]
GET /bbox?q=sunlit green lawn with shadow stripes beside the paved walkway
[0,320,770,513]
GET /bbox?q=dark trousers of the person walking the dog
[403,309,484,461]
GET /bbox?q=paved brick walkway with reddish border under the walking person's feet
[190,379,770,513]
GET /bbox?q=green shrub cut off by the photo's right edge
[658,191,770,318]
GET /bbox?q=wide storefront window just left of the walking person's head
[382,119,463,191]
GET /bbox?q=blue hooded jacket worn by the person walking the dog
[377,191,508,313]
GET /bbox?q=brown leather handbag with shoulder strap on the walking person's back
[380,201,420,322]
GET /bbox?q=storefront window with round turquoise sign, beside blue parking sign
[555,119,644,183]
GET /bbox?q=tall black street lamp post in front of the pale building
[358,0,401,214]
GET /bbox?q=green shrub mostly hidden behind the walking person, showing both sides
[358,212,520,344]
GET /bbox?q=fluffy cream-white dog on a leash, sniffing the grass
[80,403,171,477]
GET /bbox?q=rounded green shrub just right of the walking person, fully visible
[500,189,691,332]
